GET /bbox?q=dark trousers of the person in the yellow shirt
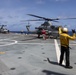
[59,46,70,66]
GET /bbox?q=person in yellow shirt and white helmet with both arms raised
[59,27,76,69]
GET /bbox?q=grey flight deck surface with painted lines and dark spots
[0,33,76,75]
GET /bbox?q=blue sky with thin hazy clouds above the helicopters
[0,0,76,31]
